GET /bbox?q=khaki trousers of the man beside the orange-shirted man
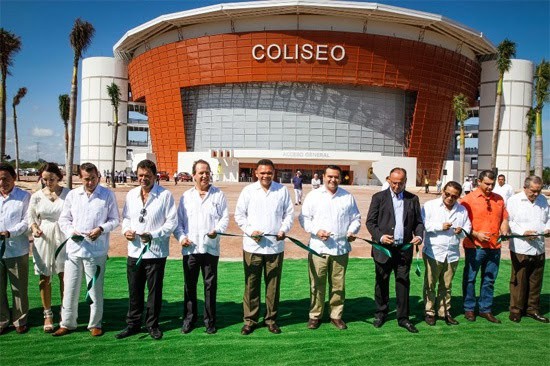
[422,254,458,317]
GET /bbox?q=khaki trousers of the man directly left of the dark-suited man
[308,253,349,319]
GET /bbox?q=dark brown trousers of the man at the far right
[510,251,545,314]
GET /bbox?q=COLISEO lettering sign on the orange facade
[252,43,346,61]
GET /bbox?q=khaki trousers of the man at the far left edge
[0,254,29,329]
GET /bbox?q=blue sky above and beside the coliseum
[0,0,550,166]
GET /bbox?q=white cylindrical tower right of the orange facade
[478,60,534,191]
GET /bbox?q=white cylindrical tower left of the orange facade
[80,57,128,174]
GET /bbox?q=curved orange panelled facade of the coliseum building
[129,31,481,182]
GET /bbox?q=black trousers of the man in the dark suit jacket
[374,248,412,324]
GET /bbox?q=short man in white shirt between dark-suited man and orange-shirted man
[422,181,472,326]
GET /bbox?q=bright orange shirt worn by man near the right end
[460,188,508,249]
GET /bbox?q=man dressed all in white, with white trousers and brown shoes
[52,163,119,337]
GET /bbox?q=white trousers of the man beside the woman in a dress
[59,255,107,330]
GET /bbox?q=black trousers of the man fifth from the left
[183,253,220,327]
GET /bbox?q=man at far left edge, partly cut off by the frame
[0,163,31,334]
